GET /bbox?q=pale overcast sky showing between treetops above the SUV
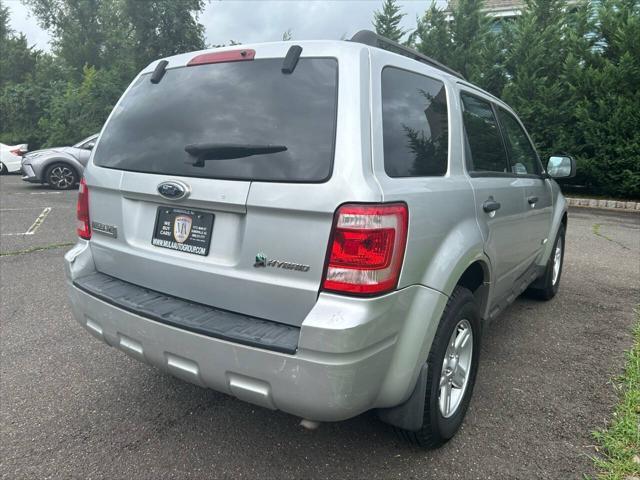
[3,0,445,50]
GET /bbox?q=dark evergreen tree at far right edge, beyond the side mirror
[567,0,640,198]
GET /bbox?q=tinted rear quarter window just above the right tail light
[382,67,449,177]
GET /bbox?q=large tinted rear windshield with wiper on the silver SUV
[94,58,338,182]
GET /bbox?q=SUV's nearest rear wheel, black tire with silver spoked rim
[397,286,481,448]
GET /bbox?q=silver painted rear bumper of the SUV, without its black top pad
[65,242,446,421]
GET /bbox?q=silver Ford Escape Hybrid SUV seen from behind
[66,31,575,447]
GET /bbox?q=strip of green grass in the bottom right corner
[593,306,640,480]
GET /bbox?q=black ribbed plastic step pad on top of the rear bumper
[73,272,300,354]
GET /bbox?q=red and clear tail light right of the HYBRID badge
[322,203,409,295]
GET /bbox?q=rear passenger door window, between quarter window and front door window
[461,93,508,173]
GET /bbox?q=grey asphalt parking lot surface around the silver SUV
[0,176,640,479]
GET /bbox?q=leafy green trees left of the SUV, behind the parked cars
[0,0,205,149]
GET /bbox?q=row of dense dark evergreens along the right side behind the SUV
[384,0,640,198]
